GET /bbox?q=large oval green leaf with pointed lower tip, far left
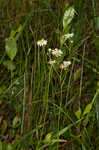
[5,38,17,60]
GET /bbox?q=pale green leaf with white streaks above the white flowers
[63,7,75,29]
